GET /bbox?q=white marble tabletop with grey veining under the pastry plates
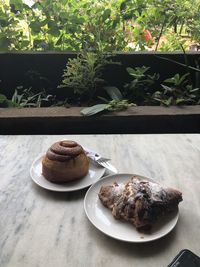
[0,135,200,267]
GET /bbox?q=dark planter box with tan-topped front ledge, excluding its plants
[0,52,200,134]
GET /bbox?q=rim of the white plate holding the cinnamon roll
[29,153,106,193]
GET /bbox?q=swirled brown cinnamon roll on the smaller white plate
[42,140,89,183]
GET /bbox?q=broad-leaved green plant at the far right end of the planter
[152,73,200,106]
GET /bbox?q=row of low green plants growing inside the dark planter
[0,51,200,115]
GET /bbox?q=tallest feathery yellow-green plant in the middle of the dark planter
[58,51,113,103]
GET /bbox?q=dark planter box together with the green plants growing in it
[0,52,200,133]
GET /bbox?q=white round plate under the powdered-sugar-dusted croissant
[84,174,178,243]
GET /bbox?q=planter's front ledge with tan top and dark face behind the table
[0,105,200,134]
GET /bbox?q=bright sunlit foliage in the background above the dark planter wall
[0,0,200,52]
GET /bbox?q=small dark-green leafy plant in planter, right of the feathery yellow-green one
[124,66,159,105]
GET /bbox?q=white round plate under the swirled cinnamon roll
[30,155,105,192]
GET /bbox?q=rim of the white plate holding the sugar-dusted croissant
[83,173,179,243]
